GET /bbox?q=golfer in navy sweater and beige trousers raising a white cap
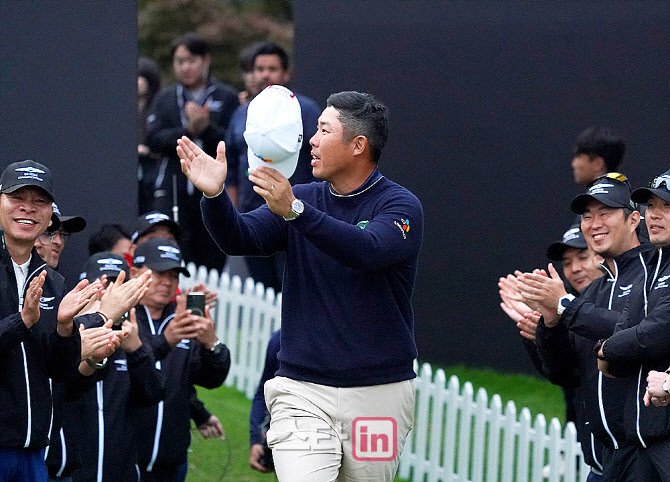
[177,86,423,482]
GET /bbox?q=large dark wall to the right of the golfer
[295,0,670,370]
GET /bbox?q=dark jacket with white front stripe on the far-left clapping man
[0,238,81,449]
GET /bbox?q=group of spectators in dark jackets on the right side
[499,127,670,482]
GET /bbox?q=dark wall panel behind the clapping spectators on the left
[0,0,137,286]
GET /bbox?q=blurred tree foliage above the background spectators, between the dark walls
[137,0,293,89]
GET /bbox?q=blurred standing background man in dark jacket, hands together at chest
[147,33,239,271]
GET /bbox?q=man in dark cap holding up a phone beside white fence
[130,238,230,481]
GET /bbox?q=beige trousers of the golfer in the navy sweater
[265,377,414,482]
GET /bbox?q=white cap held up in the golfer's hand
[244,85,302,179]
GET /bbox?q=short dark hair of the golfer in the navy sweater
[327,91,389,162]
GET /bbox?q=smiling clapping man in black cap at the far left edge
[0,160,99,481]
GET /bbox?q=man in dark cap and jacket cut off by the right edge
[597,171,670,481]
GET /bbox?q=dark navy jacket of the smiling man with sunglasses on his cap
[537,244,654,470]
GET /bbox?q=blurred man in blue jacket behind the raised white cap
[225,41,322,291]
